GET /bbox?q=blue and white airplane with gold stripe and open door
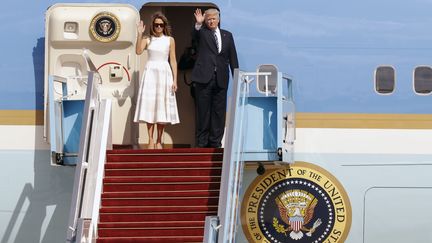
[0,0,432,243]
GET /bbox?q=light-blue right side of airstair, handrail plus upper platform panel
[204,65,295,243]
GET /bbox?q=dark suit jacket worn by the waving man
[191,24,238,88]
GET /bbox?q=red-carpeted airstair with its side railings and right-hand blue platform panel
[63,57,295,243]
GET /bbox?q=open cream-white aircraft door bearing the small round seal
[44,4,139,164]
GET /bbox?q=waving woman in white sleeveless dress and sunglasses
[134,12,180,149]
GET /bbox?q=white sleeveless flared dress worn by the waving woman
[134,36,180,124]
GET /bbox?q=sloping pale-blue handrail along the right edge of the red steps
[214,69,271,243]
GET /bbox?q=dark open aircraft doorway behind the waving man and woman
[135,2,219,148]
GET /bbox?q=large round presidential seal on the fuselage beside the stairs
[241,162,351,243]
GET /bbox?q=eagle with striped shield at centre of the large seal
[273,190,322,240]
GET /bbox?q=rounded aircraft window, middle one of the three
[375,66,396,94]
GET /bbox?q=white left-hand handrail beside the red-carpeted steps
[66,50,111,243]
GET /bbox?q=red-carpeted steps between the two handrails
[97,148,223,243]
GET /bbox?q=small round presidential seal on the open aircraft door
[90,12,120,42]
